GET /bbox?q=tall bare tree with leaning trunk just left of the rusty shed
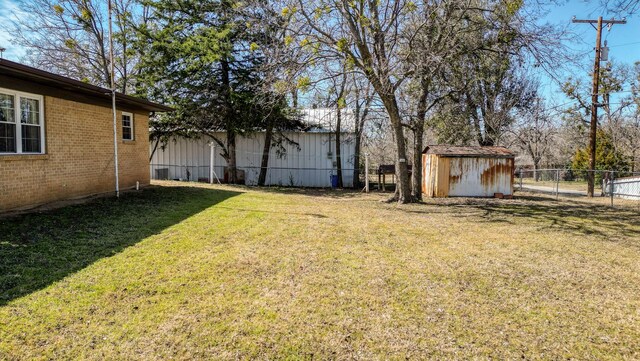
[289,0,415,203]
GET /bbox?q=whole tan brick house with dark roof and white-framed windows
[0,59,171,212]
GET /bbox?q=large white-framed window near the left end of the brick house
[0,89,44,154]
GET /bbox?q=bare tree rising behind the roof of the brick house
[8,0,140,93]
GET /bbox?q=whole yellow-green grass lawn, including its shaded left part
[0,183,640,360]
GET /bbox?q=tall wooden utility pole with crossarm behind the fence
[572,16,627,197]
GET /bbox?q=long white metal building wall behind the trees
[150,132,355,187]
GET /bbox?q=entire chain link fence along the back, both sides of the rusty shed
[150,164,640,207]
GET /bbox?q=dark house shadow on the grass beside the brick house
[0,187,241,306]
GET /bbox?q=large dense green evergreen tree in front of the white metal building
[136,0,290,183]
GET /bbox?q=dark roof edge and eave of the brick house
[0,59,173,112]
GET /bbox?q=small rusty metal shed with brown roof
[422,145,515,197]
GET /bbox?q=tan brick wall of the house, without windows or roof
[0,96,150,212]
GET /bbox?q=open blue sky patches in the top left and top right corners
[0,0,640,106]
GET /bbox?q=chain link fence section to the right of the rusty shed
[514,169,640,206]
